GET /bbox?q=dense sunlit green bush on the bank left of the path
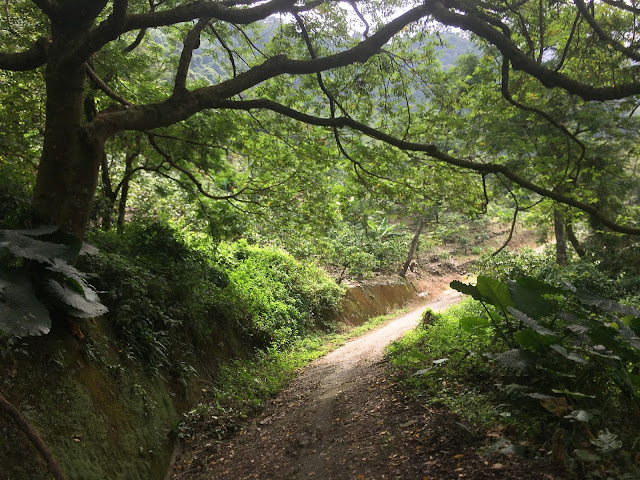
[84,219,342,374]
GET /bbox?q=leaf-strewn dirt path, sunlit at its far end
[173,290,555,480]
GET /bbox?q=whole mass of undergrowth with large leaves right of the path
[388,251,640,479]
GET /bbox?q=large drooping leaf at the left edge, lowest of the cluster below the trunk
[0,270,51,337]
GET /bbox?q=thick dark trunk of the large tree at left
[33,25,104,239]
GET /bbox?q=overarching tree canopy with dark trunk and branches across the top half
[0,0,640,238]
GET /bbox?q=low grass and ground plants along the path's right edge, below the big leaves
[387,299,640,480]
